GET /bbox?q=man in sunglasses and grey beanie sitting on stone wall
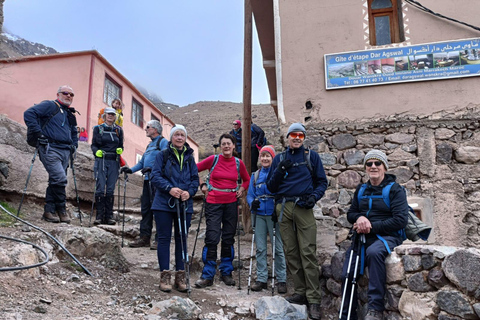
[341,149,408,320]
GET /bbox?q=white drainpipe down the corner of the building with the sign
[273,0,286,124]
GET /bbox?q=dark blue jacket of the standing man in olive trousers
[267,145,328,207]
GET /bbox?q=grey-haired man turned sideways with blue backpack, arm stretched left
[120,120,168,250]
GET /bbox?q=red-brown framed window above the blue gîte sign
[368,0,405,46]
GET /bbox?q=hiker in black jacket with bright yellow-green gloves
[92,108,123,225]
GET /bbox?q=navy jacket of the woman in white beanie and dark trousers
[151,142,199,213]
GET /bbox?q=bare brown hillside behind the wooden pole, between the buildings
[167,101,280,158]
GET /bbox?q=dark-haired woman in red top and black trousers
[195,133,250,288]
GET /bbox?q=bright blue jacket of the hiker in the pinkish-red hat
[247,168,275,216]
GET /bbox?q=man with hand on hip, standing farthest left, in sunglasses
[23,85,78,223]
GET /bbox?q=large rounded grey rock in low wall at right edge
[442,249,480,299]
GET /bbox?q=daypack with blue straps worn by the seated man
[357,182,432,248]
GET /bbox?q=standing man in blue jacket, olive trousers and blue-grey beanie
[267,123,328,320]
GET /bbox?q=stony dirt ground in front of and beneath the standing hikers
[0,198,293,320]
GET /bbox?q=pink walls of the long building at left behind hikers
[0,51,198,166]
